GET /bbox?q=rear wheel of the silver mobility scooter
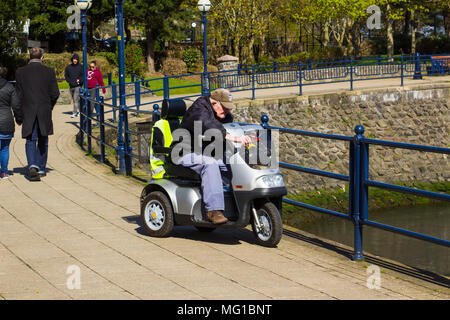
[141,191,174,237]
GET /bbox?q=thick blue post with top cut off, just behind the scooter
[116,0,131,174]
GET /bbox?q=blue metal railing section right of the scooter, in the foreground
[261,116,450,260]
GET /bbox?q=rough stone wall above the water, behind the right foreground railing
[230,84,450,193]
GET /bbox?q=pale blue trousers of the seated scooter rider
[179,153,231,211]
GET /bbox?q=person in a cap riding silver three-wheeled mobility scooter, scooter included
[141,89,287,246]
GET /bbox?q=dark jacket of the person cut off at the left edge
[0,77,23,135]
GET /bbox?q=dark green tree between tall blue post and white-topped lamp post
[124,0,196,73]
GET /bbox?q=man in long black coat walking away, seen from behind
[16,47,59,181]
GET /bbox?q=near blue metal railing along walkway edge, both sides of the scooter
[75,79,450,260]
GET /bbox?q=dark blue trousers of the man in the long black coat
[25,119,48,172]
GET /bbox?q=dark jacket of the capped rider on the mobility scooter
[173,96,233,152]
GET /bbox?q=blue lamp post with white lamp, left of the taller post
[75,0,92,147]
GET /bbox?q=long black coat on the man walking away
[16,60,59,138]
